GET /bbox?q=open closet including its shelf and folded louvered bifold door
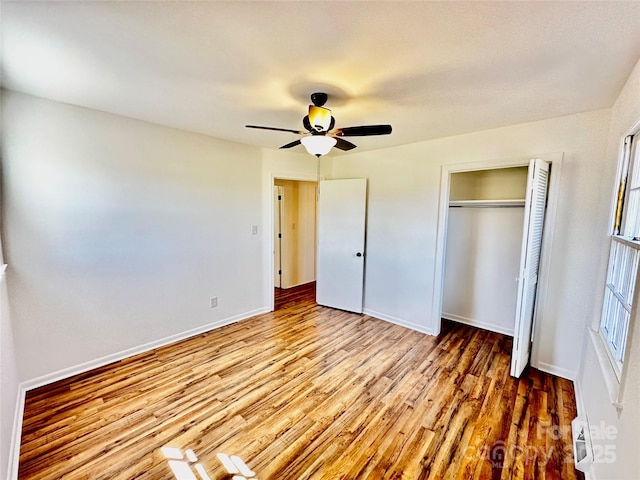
[438,159,562,377]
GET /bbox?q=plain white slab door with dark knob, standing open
[316,178,367,313]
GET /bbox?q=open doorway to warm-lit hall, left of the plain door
[273,178,318,310]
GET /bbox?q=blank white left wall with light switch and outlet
[2,92,264,381]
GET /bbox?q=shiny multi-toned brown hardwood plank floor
[19,285,582,480]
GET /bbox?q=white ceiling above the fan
[0,0,640,151]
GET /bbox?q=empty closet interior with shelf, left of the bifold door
[442,167,529,336]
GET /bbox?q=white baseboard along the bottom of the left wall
[7,307,271,480]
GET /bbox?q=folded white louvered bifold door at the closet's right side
[511,159,549,378]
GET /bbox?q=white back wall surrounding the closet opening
[333,106,610,378]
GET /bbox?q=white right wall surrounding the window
[576,55,640,480]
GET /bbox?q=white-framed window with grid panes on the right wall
[600,135,640,381]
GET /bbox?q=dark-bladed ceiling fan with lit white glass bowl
[246,92,391,157]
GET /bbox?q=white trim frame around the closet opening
[432,152,563,367]
